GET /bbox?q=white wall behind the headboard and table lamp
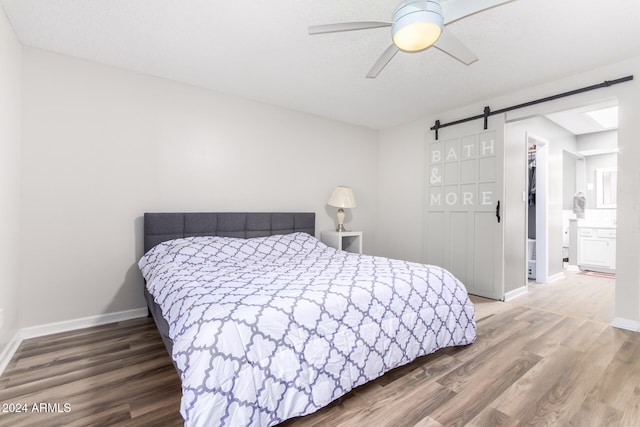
[21,48,378,327]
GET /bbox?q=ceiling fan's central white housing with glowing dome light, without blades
[391,0,444,52]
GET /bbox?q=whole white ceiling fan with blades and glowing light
[309,0,513,79]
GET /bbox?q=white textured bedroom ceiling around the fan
[2,0,640,129]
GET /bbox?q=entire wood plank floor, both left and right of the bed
[0,273,640,427]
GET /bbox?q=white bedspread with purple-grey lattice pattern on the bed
[139,233,476,426]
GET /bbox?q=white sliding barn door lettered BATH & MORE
[423,115,505,300]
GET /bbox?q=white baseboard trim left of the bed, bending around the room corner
[0,307,149,375]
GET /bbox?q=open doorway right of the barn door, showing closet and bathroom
[507,100,617,286]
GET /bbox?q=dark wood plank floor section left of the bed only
[0,318,182,427]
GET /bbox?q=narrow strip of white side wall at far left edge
[0,8,21,354]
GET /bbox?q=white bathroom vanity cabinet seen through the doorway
[578,227,616,272]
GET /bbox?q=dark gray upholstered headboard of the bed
[144,212,316,253]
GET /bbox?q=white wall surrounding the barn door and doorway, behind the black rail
[377,58,640,325]
